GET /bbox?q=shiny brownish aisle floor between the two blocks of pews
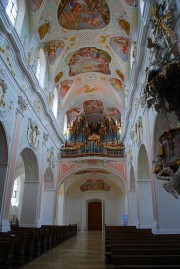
[23,231,105,269]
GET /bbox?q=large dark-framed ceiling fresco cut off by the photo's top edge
[57,0,110,30]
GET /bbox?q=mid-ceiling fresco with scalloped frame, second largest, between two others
[65,47,111,76]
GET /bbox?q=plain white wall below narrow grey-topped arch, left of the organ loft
[42,190,55,224]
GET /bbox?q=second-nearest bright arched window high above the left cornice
[36,49,46,88]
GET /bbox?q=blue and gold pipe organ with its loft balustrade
[61,116,124,158]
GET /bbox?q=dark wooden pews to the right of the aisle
[105,226,180,269]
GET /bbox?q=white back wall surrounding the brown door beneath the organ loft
[65,188,126,230]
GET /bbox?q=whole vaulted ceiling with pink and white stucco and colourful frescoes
[29,0,138,127]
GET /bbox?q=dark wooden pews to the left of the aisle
[0,222,77,269]
